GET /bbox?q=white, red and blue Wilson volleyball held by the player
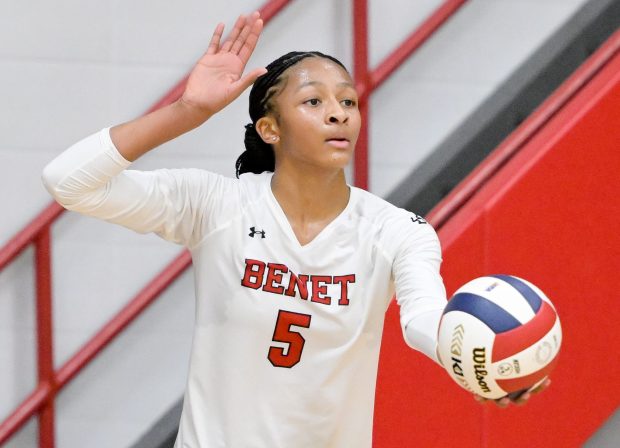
[438,275,562,399]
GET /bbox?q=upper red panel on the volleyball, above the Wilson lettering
[491,300,557,362]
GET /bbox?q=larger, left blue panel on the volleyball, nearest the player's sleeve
[443,292,521,333]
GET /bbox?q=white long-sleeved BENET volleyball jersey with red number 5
[43,129,446,448]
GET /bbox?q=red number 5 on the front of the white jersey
[267,310,312,369]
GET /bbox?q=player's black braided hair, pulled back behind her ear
[235,51,347,177]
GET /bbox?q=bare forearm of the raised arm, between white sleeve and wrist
[110,100,209,162]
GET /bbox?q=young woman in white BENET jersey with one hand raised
[43,13,544,448]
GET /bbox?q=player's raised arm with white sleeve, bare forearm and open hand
[43,13,264,244]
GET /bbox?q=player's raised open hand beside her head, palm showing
[181,12,266,117]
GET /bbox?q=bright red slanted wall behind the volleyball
[374,48,620,448]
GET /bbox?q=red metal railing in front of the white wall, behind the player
[0,0,467,448]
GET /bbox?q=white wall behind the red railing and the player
[0,0,585,448]
